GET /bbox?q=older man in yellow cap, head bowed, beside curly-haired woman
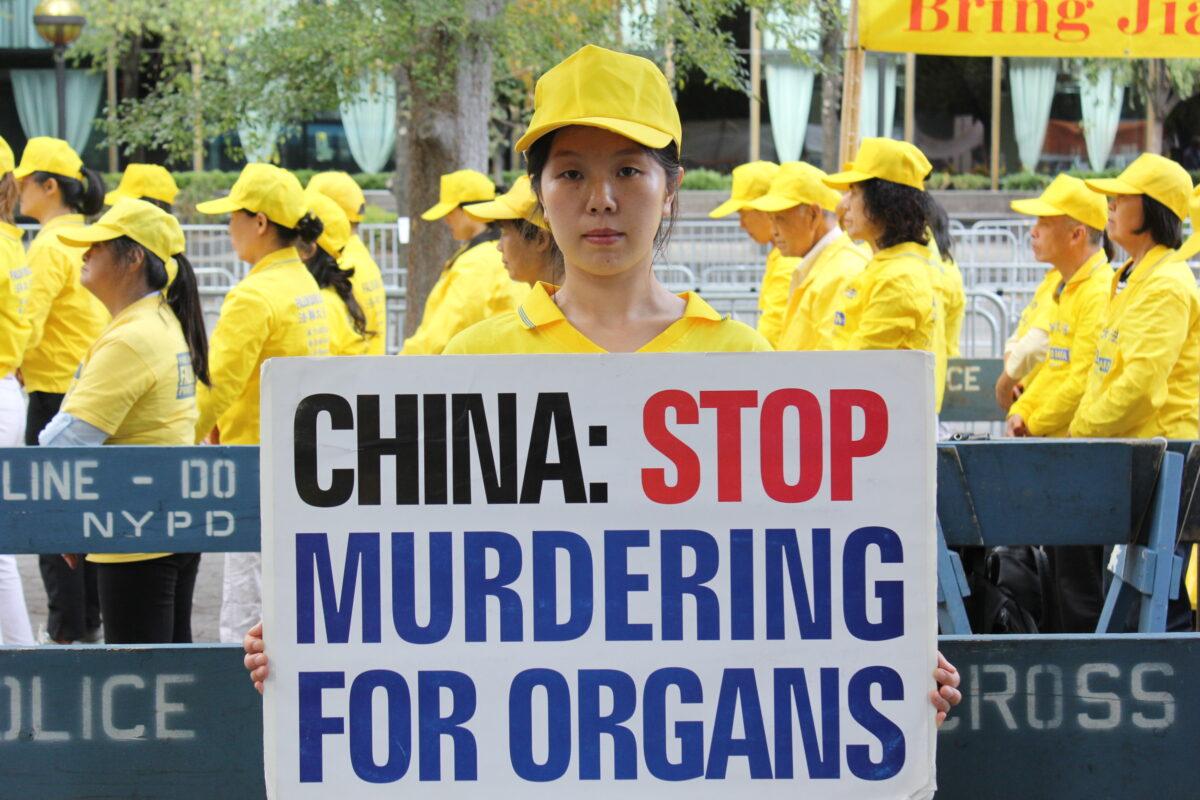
[750,161,870,350]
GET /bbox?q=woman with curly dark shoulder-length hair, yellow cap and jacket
[824,139,946,410]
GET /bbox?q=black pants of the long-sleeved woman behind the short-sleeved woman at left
[25,392,100,642]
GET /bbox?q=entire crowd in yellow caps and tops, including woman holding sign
[7,46,1200,716]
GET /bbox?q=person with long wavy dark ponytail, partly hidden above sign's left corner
[298,190,371,355]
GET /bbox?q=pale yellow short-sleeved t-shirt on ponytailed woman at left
[62,291,199,564]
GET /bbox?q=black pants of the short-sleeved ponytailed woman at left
[95,553,200,644]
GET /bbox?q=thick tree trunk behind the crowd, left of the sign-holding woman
[404,0,503,337]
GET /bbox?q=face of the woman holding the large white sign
[540,126,678,276]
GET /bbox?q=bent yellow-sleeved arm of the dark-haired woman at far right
[1070,282,1194,438]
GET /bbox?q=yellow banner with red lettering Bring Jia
[858,0,1200,59]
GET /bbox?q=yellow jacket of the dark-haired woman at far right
[1070,246,1200,439]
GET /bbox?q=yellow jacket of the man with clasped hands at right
[1008,251,1112,437]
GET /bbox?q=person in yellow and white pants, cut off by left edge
[0,137,36,645]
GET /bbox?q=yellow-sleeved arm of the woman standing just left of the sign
[196,289,271,443]
